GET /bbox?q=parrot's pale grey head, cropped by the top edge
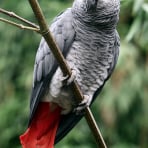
[73,0,120,25]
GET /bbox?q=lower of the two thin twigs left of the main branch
[0,17,40,33]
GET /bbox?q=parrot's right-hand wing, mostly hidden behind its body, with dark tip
[55,31,120,144]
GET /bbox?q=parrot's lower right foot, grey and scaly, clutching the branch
[74,95,91,115]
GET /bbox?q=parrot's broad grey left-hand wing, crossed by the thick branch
[29,9,75,125]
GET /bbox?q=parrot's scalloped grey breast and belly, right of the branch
[67,30,115,96]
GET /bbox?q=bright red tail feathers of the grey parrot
[20,102,61,148]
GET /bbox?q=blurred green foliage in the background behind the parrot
[0,0,148,148]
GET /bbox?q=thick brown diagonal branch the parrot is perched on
[29,0,107,148]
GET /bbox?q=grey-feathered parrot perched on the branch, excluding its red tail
[19,0,120,146]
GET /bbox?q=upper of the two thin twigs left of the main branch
[0,8,39,29]
